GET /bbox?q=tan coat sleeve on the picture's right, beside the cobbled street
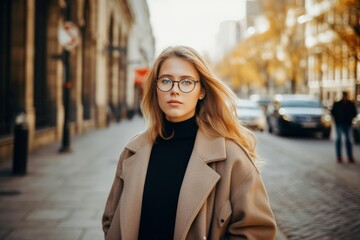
[226,161,276,240]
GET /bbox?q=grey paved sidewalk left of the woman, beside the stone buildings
[0,117,144,240]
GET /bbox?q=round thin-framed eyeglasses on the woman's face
[155,77,200,93]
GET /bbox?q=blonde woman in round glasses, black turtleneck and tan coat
[102,47,276,240]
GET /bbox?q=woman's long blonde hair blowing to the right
[141,46,256,159]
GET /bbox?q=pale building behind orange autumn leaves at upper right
[298,0,360,105]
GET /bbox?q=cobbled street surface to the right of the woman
[258,134,360,240]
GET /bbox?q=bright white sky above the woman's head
[147,0,245,58]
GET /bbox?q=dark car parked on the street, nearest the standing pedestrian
[267,94,332,138]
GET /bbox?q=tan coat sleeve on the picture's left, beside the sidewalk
[102,149,128,236]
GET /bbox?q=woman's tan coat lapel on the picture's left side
[120,130,152,239]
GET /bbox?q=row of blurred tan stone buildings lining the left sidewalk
[0,0,154,159]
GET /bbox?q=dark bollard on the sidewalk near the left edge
[12,113,29,175]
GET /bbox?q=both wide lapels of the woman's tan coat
[120,129,226,239]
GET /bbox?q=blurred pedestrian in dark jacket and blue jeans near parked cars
[331,91,356,163]
